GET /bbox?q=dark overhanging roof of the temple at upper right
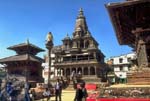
[106,0,150,47]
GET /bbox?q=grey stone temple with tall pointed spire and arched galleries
[52,8,106,82]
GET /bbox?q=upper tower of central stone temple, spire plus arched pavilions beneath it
[72,8,98,51]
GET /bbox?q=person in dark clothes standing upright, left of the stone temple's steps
[55,79,62,101]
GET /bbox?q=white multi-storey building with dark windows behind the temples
[108,52,136,83]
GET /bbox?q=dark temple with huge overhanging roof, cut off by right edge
[106,0,150,84]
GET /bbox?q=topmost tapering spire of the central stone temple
[75,8,88,35]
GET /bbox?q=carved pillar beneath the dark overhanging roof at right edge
[132,28,150,68]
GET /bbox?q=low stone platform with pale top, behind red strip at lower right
[103,84,150,99]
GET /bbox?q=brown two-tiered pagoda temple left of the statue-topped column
[0,41,44,84]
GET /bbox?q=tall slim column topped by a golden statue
[45,32,53,87]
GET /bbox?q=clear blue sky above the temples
[0,0,132,59]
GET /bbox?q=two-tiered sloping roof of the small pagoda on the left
[0,42,44,63]
